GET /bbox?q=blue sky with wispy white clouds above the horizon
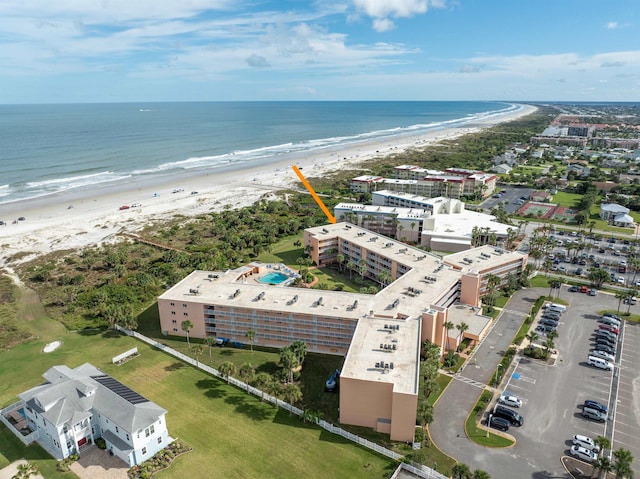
[0,0,640,104]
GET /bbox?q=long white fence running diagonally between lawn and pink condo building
[116,326,447,479]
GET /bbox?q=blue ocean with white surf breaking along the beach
[0,102,518,205]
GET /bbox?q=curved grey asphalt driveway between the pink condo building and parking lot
[429,288,548,477]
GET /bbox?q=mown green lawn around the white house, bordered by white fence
[0,288,394,479]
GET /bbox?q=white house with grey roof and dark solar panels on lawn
[19,363,170,467]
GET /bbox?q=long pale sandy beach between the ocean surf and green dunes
[0,105,536,267]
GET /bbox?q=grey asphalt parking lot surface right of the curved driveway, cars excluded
[496,287,640,477]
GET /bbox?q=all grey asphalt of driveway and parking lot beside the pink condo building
[429,287,640,479]
